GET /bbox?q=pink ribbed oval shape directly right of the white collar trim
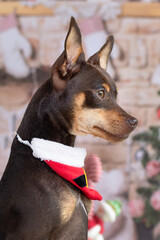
[85,154,102,183]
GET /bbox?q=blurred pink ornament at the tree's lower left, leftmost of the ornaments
[129,199,145,218]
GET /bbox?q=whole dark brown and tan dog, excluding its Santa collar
[0,18,137,240]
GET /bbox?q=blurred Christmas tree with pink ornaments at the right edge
[129,126,160,227]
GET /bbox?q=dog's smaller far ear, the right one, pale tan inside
[88,35,114,71]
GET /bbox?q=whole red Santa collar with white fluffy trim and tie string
[17,134,102,201]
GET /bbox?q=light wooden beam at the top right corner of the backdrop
[121,2,160,17]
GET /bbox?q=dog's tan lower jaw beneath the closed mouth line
[92,126,129,142]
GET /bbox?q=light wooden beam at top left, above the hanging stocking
[0,1,53,15]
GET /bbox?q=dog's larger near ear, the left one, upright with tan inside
[52,17,85,91]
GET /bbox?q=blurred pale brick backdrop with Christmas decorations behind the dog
[0,0,160,240]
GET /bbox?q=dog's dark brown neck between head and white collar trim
[17,82,75,146]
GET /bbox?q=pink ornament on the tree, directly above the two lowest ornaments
[146,160,160,177]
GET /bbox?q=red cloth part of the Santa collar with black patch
[45,160,102,201]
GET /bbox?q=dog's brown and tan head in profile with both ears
[52,18,137,142]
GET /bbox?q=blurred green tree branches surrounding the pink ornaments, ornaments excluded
[133,126,160,228]
